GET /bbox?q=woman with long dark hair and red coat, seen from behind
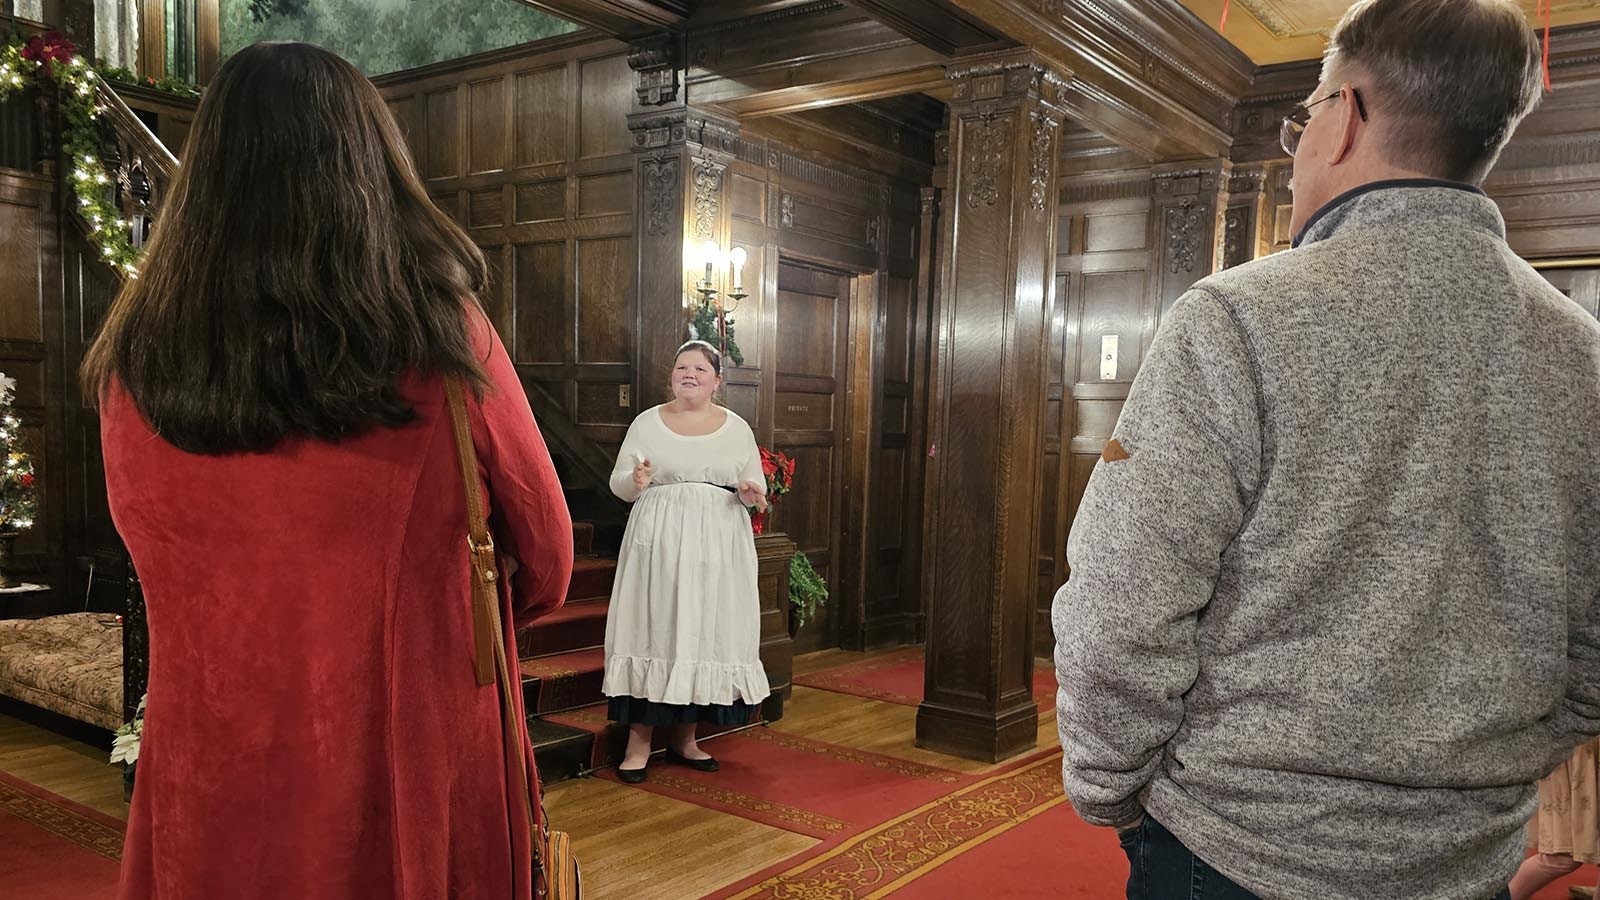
[83,43,573,900]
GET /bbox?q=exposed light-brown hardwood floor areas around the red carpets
[0,650,1075,900]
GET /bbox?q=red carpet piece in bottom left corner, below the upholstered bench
[0,772,123,900]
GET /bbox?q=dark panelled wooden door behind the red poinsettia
[773,261,850,653]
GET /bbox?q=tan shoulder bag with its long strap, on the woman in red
[445,376,582,900]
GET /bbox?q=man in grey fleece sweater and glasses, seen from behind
[1053,0,1600,900]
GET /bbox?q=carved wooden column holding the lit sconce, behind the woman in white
[627,35,739,408]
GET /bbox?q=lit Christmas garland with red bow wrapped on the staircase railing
[0,32,159,277]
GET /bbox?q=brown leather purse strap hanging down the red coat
[445,376,542,866]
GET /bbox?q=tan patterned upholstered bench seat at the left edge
[0,612,123,730]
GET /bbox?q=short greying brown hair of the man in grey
[1323,0,1542,184]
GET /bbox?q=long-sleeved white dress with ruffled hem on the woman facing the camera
[602,407,770,706]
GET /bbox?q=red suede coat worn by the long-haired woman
[101,318,573,900]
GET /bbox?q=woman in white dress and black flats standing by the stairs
[603,341,768,783]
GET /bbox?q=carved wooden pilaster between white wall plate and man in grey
[1150,160,1232,315]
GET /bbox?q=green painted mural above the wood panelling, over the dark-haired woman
[221,0,578,75]
